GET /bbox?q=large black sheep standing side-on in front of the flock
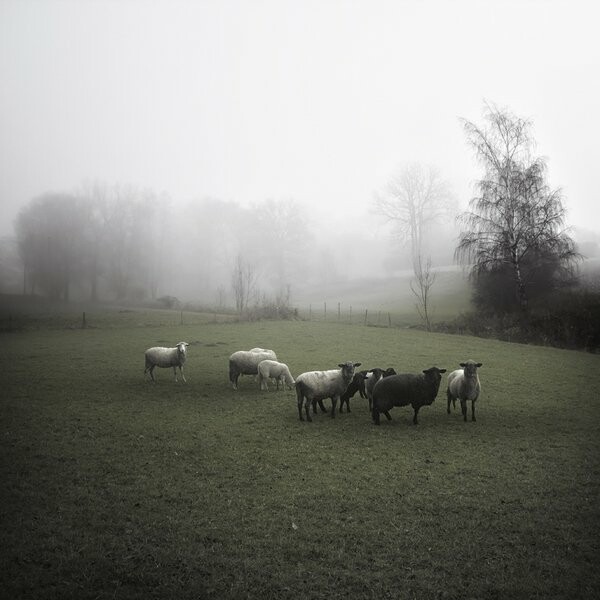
[372,367,446,425]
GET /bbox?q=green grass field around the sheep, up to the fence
[0,312,600,600]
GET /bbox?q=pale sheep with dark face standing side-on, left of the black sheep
[296,362,360,421]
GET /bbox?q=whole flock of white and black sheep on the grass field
[144,342,482,425]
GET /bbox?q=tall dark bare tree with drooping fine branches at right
[456,105,579,310]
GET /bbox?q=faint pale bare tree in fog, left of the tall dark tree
[374,163,451,274]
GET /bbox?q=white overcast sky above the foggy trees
[0,0,600,234]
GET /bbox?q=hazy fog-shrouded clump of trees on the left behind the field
[10,183,318,310]
